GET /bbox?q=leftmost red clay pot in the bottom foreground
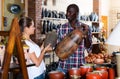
[48,71,65,79]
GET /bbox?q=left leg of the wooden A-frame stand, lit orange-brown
[2,19,16,79]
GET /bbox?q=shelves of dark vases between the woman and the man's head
[40,5,68,34]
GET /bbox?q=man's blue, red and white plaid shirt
[57,21,92,70]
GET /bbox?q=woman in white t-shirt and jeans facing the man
[19,17,51,79]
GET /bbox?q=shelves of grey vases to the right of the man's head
[80,12,103,53]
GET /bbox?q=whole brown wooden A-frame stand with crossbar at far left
[0,18,28,79]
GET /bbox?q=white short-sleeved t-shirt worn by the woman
[25,40,46,79]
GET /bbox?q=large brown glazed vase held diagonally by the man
[55,30,83,60]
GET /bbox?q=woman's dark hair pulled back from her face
[19,17,33,32]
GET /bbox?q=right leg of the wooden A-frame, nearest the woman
[16,19,29,79]
